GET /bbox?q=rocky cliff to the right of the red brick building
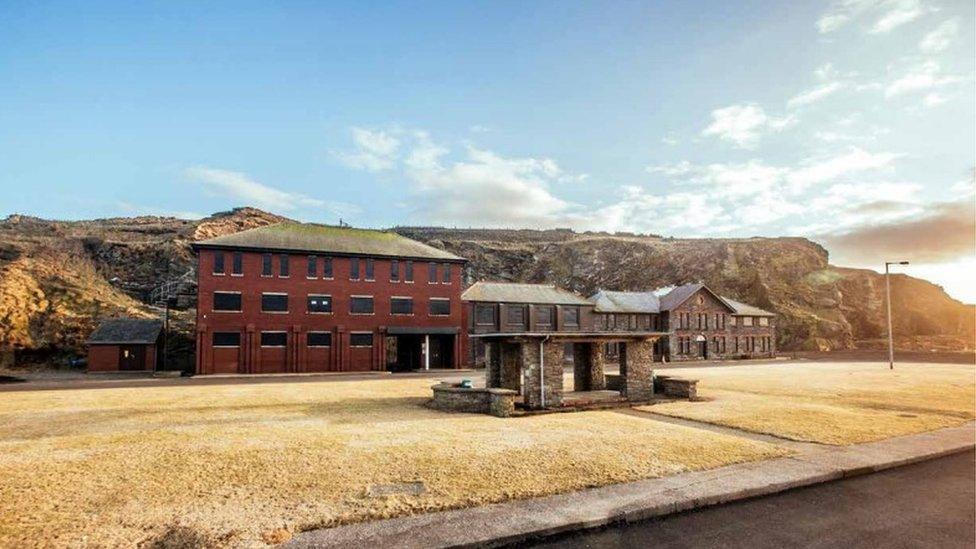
[397,227,976,350]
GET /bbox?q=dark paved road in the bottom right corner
[522,452,976,549]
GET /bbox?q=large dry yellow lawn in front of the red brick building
[0,379,783,547]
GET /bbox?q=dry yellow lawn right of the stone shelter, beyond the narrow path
[644,362,976,444]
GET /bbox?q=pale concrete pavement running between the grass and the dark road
[289,422,976,548]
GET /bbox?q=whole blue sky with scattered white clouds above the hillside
[0,0,976,301]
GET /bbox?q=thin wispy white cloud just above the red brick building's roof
[186,166,359,215]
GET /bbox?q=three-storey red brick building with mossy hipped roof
[193,223,466,374]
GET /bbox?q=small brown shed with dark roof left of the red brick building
[88,318,163,372]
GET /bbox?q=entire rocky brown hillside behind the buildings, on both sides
[0,208,974,365]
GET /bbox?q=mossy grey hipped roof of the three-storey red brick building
[193,221,465,261]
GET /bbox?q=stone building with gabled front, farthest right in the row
[590,283,776,361]
